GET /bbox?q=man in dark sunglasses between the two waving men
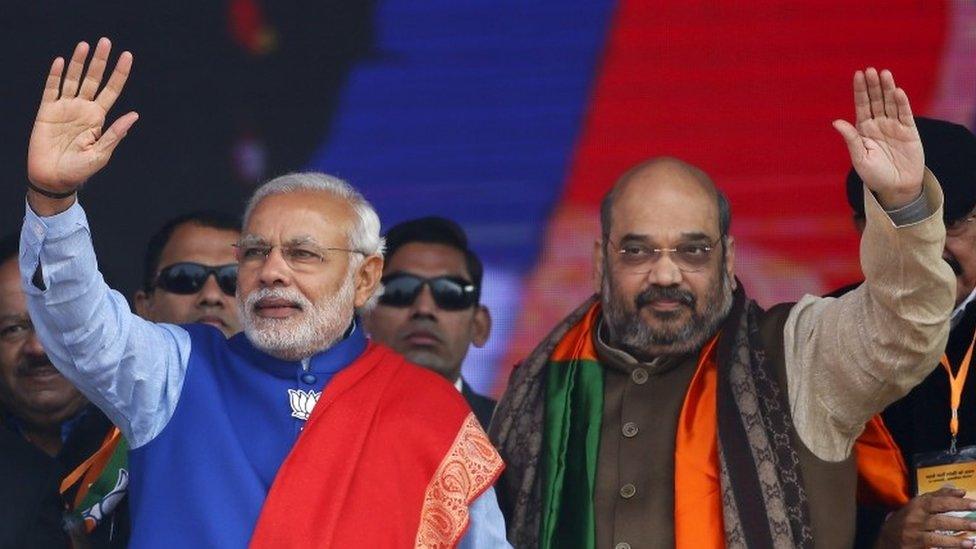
[365,217,495,429]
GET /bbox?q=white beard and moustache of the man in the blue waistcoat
[237,269,356,360]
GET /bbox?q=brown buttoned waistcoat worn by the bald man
[594,306,857,549]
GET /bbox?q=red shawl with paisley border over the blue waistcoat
[251,343,504,549]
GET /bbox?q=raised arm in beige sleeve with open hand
[784,69,954,461]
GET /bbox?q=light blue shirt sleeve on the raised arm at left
[19,202,190,448]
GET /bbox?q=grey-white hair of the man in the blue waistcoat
[244,172,384,256]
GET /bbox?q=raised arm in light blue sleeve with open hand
[20,38,189,447]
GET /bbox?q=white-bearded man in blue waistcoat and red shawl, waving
[20,38,507,548]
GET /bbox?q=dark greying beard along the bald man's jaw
[601,258,732,361]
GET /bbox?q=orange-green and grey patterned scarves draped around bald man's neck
[491,290,813,548]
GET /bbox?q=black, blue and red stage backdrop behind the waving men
[0,0,976,394]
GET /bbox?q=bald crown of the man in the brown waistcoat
[600,156,732,243]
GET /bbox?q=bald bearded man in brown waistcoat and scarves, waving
[490,69,954,549]
